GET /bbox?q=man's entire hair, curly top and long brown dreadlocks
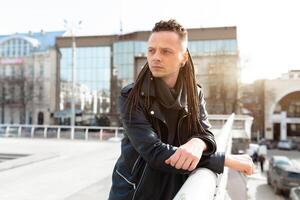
[126,20,205,140]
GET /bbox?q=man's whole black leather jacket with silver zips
[109,84,224,200]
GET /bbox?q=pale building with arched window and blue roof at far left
[0,31,63,124]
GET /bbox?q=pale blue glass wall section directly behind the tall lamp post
[60,46,111,125]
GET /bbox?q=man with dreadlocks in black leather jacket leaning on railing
[109,20,253,200]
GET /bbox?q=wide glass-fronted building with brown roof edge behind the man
[56,27,240,125]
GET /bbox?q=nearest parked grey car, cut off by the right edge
[267,156,300,194]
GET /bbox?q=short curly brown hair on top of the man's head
[152,19,188,50]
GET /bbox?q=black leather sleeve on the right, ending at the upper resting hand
[193,86,217,155]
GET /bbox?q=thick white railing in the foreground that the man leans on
[174,114,234,200]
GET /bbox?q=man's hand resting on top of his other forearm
[165,138,207,171]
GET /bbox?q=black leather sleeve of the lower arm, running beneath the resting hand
[119,95,222,174]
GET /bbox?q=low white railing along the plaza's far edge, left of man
[0,124,123,141]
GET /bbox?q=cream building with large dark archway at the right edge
[264,70,300,141]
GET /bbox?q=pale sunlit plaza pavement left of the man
[0,138,120,200]
